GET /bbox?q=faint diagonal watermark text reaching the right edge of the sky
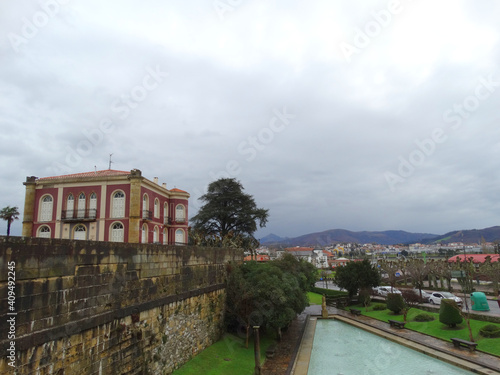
[384,74,500,192]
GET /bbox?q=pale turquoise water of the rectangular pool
[308,319,473,375]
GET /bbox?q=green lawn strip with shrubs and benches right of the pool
[356,303,500,356]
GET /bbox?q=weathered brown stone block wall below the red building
[0,237,243,375]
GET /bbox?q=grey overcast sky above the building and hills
[0,0,500,237]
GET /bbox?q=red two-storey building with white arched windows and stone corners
[22,169,189,244]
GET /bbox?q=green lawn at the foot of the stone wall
[173,333,274,375]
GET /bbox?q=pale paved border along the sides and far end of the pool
[289,305,500,375]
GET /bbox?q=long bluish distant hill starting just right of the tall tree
[260,229,438,246]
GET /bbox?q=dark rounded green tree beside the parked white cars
[335,259,380,298]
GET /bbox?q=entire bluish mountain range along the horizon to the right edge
[260,226,500,246]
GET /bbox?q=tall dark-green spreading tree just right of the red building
[191,178,269,250]
